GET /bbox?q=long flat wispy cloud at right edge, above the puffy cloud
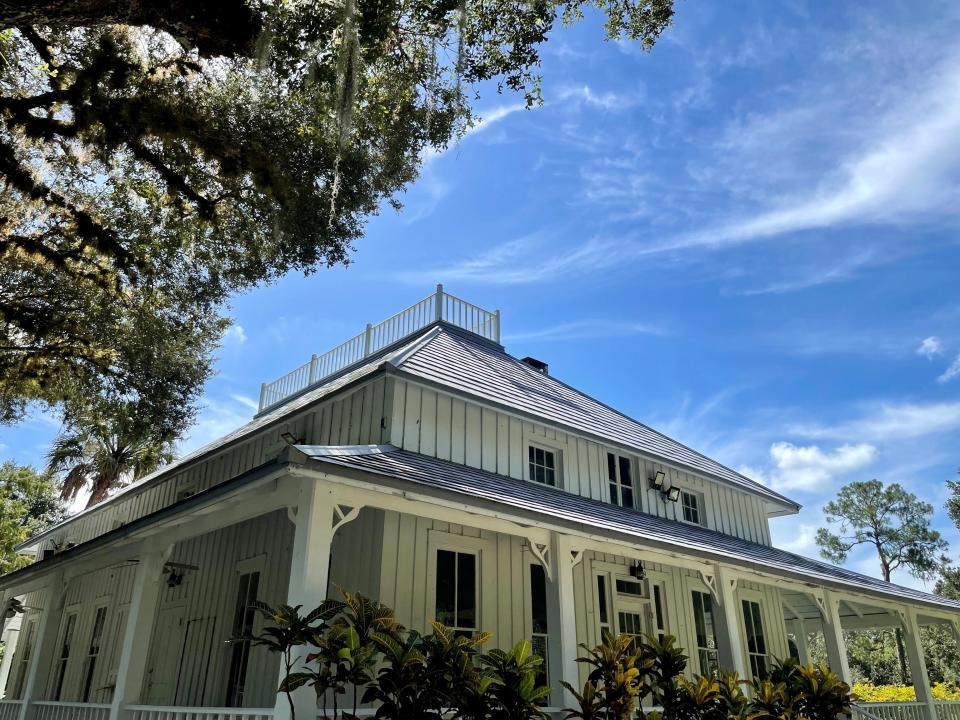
[791,402,960,442]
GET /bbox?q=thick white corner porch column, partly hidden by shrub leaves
[274,479,334,720]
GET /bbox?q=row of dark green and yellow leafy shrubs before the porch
[244,592,851,720]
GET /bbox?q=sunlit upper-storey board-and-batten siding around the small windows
[387,378,770,545]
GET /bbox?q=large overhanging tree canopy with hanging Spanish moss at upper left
[0,0,673,428]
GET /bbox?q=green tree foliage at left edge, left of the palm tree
[0,461,64,575]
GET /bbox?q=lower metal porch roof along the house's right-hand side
[297,445,960,611]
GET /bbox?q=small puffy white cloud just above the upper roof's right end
[756,442,877,491]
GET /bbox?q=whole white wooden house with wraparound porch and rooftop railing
[0,287,960,720]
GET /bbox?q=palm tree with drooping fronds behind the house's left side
[47,402,174,508]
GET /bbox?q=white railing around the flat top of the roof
[259,285,500,411]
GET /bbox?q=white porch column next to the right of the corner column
[547,533,576,707]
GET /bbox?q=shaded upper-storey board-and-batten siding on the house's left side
[36,377,392,547]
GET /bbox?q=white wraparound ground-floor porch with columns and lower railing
[0,449,960,720]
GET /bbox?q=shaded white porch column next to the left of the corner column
[110,545,173,720]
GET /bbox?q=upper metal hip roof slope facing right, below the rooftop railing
[391,325,800,510]
